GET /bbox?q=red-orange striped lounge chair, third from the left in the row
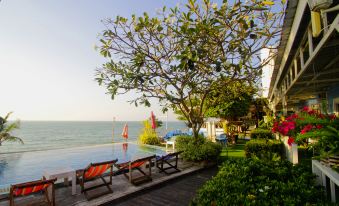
[114,155,155,185]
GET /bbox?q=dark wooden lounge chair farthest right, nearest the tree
[156,151,182,175]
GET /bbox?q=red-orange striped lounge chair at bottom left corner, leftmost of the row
[9,179,56,206]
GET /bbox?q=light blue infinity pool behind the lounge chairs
[0,143,166,188]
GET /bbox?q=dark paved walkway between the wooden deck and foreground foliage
[105,167,217,206]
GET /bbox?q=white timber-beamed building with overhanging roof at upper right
[268,0,339,114]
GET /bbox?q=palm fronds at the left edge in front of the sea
[0,112,24,146]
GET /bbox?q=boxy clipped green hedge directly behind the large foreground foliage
[245,139,284,157]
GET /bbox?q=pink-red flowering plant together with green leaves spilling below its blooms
[272,107,339,168]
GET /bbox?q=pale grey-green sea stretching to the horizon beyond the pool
[0,121,187,154]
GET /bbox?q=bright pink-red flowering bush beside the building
[272,107,339,145]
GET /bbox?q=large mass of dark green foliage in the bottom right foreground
[191,158,325,206]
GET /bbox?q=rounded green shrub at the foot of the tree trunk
[176,136,221,162]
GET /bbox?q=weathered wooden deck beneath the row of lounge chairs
[0,161,210,206]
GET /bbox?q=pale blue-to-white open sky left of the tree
[0,0,191,121]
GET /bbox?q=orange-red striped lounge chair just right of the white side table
[77,159,118,200]
